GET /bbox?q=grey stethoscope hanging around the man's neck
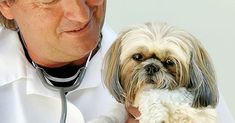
[17,30,94,123]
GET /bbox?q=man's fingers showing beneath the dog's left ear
[126,106,140,123]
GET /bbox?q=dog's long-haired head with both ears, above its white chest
[103,23,217,107]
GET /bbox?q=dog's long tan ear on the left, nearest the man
[102,35,125,103]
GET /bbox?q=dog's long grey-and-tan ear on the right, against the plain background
[188,39,218,107]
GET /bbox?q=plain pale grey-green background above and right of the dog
[106,0,235,118]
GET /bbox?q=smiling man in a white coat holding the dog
[0,0,136,123]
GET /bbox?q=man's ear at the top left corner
[0,1,14,20]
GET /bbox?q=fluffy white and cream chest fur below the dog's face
[136,88,216,123]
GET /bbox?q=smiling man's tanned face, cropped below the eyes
[8,0,106,67]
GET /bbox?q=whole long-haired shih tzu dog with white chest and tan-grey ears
[89,22,218,123]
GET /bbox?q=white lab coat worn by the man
[0,26,234,123]
